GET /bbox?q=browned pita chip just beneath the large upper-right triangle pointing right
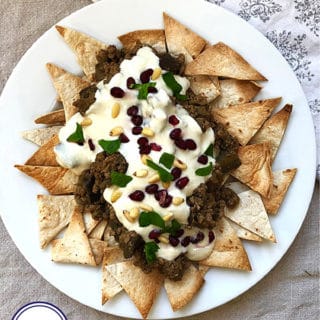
[210,79,262,108]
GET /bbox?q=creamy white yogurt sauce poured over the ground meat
[55,47,215,260]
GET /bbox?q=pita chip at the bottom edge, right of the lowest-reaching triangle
[164,265,204,311]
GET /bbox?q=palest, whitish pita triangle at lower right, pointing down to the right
[225,190,276,242]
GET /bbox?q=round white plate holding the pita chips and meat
[0,0,315,319]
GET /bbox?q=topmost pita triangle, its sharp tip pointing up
[163,13,207,62]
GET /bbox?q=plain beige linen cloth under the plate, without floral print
[0,0,320,320]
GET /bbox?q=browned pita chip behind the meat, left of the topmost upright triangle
[118,29,167,53]
